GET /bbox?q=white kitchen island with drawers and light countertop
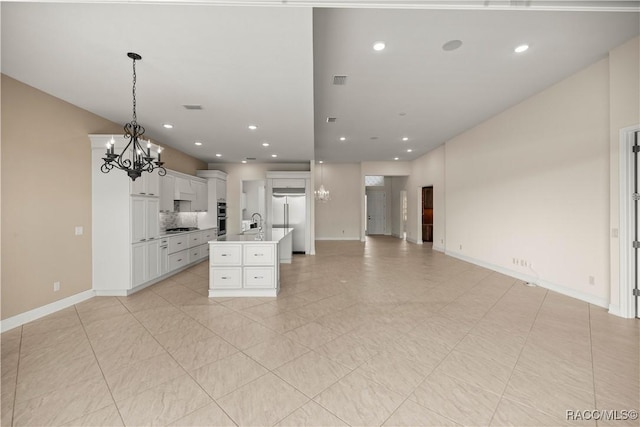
[209,228,293,297]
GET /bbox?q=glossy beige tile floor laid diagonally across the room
[1,237,640,426]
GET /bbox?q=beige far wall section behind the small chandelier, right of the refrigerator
[315,163,360,240]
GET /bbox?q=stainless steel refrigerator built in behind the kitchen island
[271,188,307,253]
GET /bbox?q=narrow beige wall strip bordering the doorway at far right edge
[609,37,640,307]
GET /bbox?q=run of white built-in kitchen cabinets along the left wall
[89,135,210,296]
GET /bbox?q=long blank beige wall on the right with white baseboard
[445,59,610,306]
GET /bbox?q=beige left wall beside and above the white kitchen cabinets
[1,75,206,319]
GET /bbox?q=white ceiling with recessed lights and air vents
[1,0,640,162]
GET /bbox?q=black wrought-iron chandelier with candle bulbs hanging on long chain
[100,52,167,181]
